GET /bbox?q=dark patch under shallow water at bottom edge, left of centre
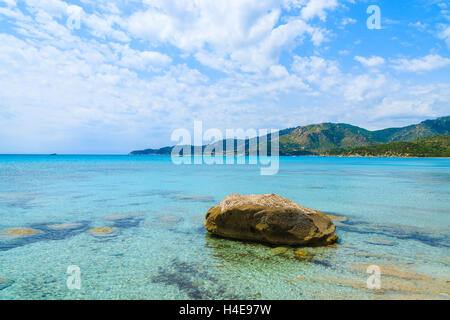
[151,258,246,300]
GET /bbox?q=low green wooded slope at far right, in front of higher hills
[329,135,450,157]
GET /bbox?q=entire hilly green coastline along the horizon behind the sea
[129,116,450,158]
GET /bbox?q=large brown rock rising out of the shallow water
[205,193,338,245]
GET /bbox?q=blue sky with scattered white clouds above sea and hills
[0,0,450,154]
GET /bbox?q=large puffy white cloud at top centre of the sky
[127,0,337,72]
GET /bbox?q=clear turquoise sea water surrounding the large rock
[0,155,450,299]
